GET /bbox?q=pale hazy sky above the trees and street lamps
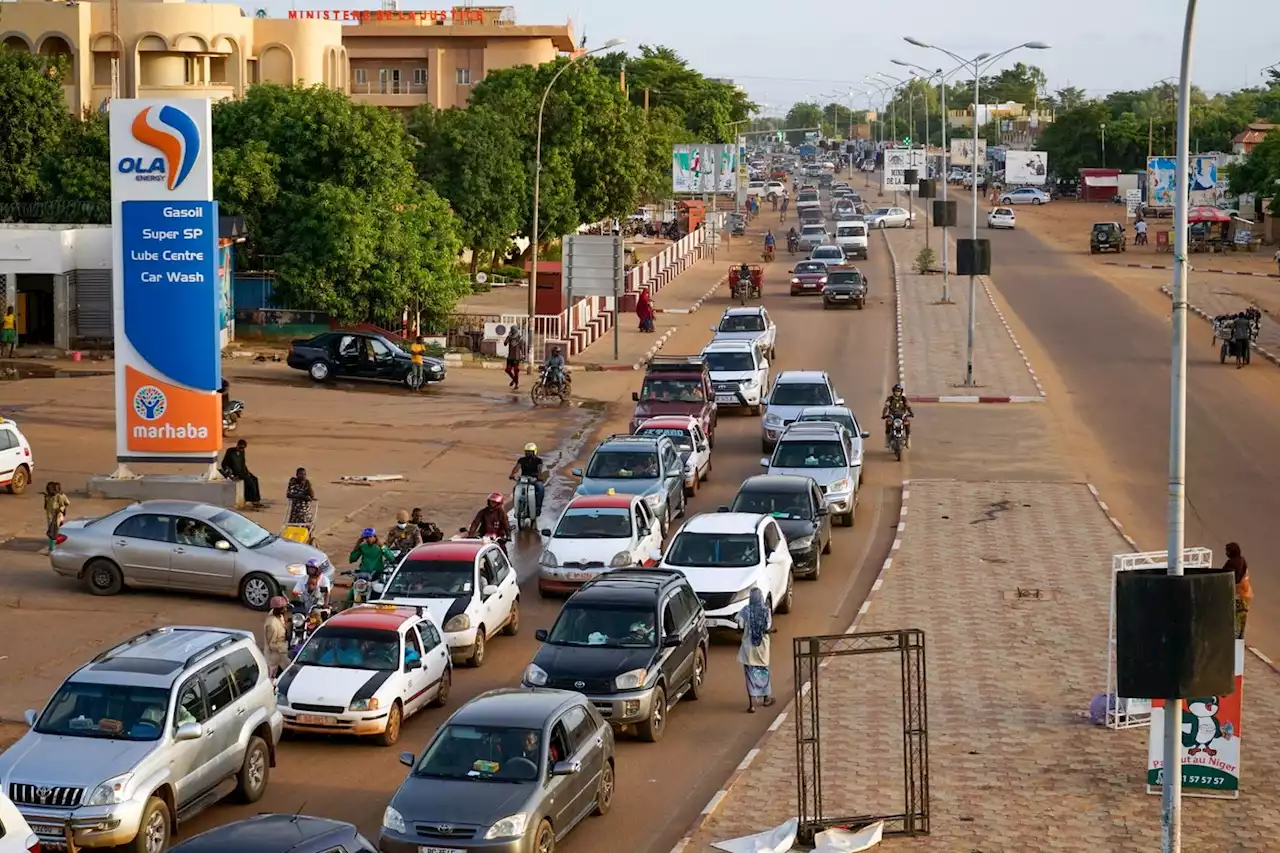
[249,0,1280,115]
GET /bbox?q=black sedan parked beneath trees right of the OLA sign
[287,332,444,388]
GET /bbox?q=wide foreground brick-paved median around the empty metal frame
[684,480,1280,853]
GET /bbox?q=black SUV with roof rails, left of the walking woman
[522,569,709,743]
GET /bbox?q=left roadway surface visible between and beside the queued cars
[162,179,901,853]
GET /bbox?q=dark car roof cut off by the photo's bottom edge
[169,815,376,853]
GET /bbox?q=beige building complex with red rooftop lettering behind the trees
[0,0,575,111]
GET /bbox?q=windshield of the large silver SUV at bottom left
[36,681,169,740]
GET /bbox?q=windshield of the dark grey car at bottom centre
[413,724,543,783]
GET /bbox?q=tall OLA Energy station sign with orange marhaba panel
[111,99,223,462]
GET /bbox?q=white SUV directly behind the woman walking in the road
[662,512,792,629]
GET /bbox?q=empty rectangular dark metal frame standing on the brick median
[792,628,929,844]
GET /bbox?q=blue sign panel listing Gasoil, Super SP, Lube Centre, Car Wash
[119,201,221,391]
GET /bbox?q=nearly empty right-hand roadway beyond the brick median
[959,205,1280,656]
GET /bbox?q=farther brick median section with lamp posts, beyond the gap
[882,222,1043,402]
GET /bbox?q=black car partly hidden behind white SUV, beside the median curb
[728,474,831,580]
